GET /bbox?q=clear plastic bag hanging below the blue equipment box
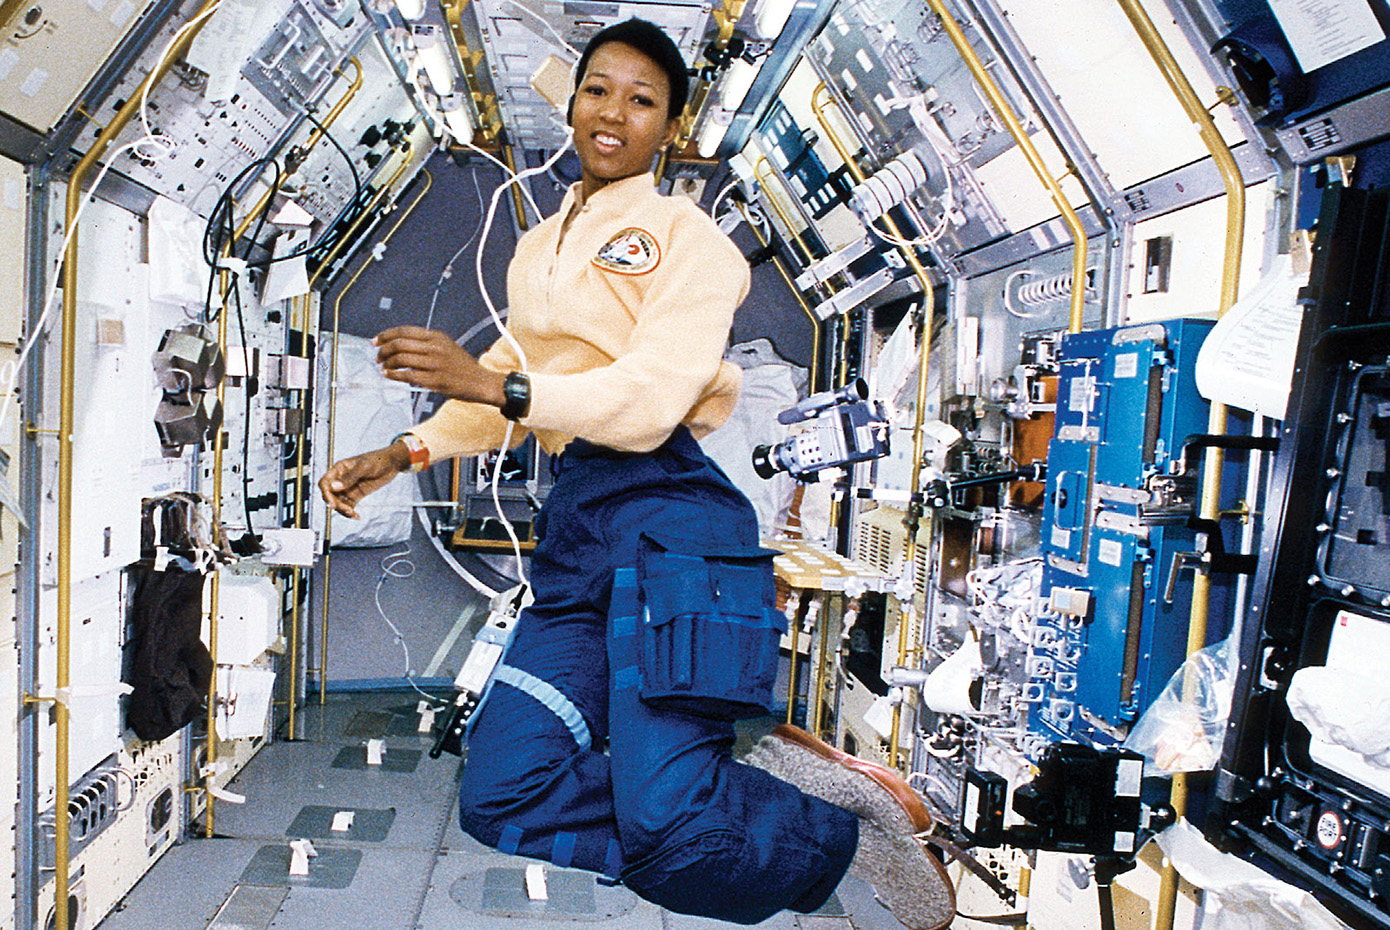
[1125,639,1236,774]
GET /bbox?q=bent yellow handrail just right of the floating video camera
[810,82,935,767]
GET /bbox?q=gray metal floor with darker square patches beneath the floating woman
[99,694,878,930]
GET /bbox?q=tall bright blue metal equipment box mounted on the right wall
[1026,320,1212,745]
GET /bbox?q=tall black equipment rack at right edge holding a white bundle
[1223,186,1390,929]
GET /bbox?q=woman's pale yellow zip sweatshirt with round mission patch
[411,174,749,462]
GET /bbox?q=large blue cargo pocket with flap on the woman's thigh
[638,534,787,720]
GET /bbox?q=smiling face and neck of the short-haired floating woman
[573,42,681,199]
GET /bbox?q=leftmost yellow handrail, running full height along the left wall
[53,0,220,911]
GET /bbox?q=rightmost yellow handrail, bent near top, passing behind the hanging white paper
[1118,0,1245,930]
